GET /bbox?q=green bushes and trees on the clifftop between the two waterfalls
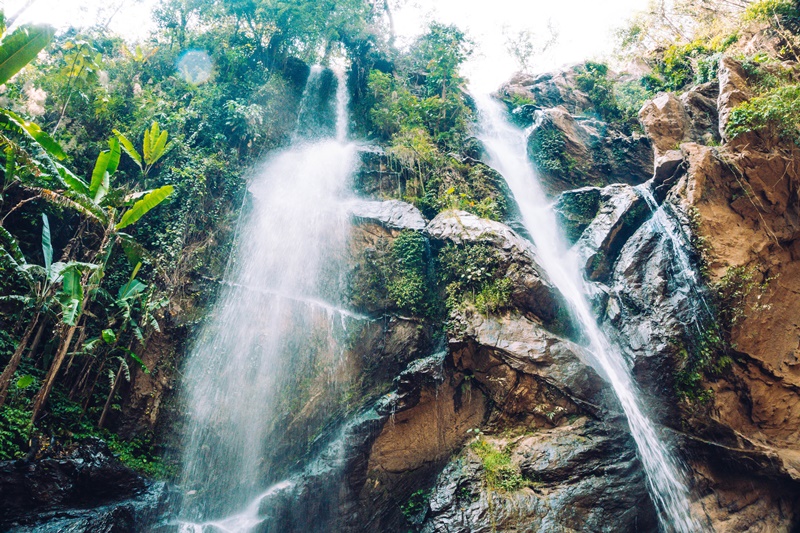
[356,23,507,220]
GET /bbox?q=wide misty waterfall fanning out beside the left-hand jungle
[180,67,359,532]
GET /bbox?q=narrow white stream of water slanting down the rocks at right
[475,95,700,533]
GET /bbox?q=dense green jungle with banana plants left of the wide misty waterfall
[0,0,388,474]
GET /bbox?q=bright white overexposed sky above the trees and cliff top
[0,0,648,90]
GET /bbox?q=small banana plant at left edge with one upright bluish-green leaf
[0,214,97,406]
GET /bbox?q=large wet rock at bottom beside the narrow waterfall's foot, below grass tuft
[421,418,658,533]
